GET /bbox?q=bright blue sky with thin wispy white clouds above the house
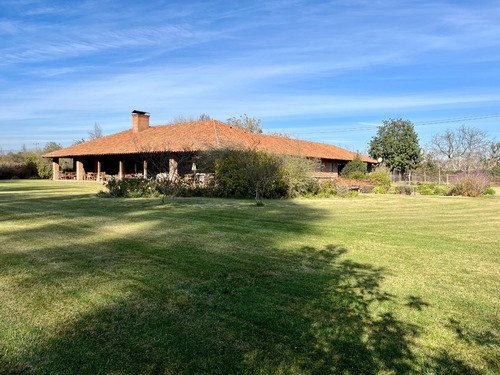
[0,0,500,152]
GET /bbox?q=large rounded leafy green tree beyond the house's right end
[368,118,422,173]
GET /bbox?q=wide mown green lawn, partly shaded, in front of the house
[0,180,500,374]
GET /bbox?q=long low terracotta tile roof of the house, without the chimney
[43,120,377,163]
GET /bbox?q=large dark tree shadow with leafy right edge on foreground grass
[1,245,426,374]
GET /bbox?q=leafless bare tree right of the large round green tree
[428,125,491,172]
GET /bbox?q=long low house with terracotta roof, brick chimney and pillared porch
[43,111,377,180]
